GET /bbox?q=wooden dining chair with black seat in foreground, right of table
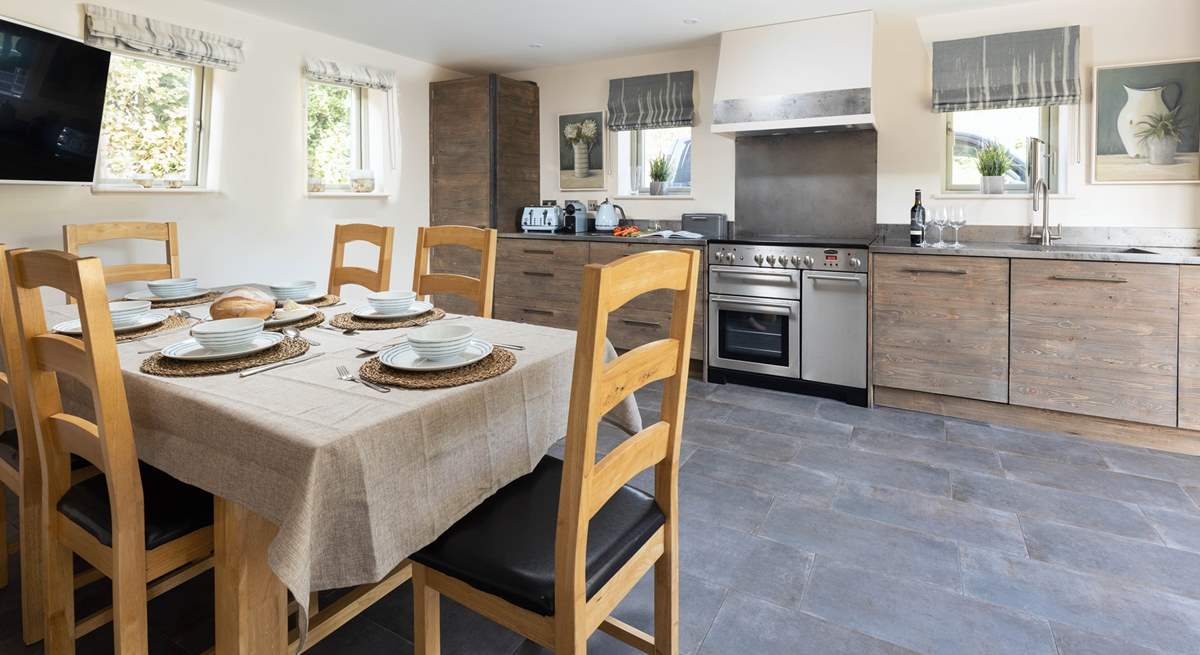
[412,251,700,655]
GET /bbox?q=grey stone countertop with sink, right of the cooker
[870,240,1200,264]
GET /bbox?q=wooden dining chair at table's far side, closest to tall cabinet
[413,226,497,318]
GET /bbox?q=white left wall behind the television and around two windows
[0,0,461,298]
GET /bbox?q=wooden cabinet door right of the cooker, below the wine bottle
[871,254,1008,402]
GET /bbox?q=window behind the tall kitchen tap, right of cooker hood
[946,107,1058,192]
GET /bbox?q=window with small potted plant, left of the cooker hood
[617,127,691,196]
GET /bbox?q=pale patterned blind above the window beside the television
[84,5,245,71]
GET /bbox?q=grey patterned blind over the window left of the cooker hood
[608,71,696,131]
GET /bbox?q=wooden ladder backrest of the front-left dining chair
[7,250,145,552]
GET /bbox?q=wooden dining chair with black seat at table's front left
[7,250,212,655]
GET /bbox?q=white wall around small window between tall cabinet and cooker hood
[509,41,733,221]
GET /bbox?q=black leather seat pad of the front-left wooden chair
[59,464,212,551]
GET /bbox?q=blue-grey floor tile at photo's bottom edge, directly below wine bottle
[804,557,1056,655]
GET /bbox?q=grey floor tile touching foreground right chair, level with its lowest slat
[683,447,838,506]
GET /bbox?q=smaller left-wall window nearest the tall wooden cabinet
[305,82,367,188]
